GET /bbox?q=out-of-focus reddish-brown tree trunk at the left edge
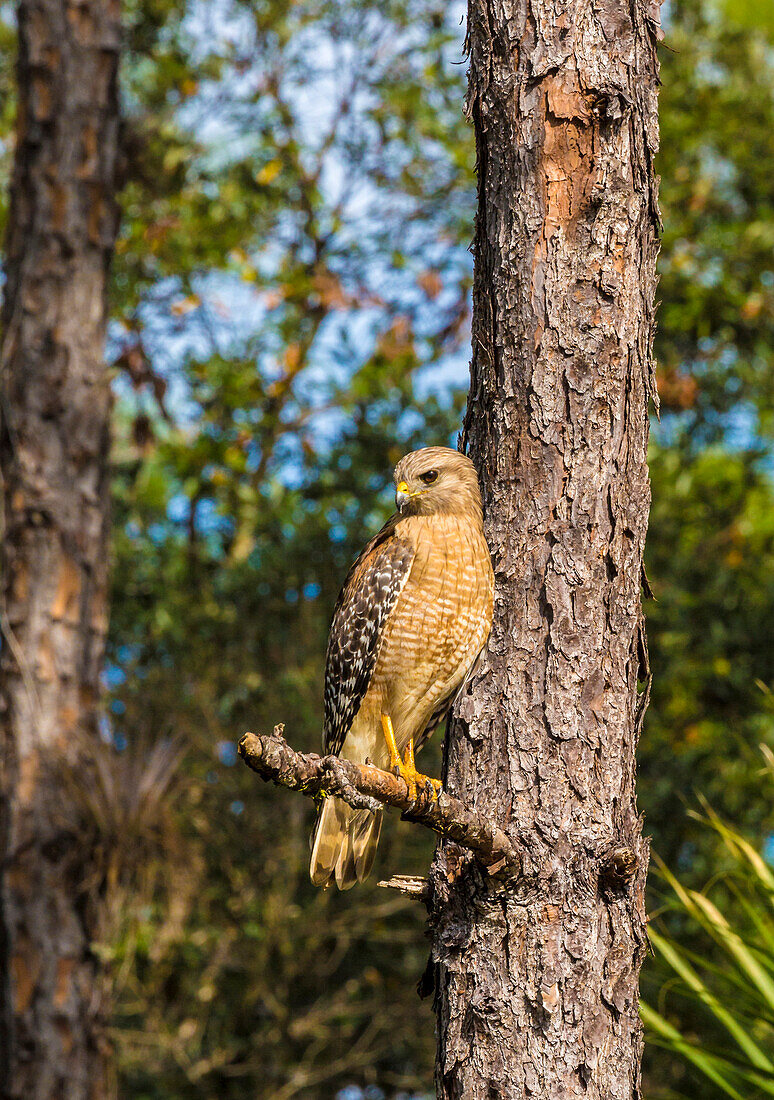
[0,0,120,1100]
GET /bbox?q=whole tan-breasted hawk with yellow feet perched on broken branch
[310,447,495,890]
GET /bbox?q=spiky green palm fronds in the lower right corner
[642,770,774,1100]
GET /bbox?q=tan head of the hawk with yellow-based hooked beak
[394,447,482,519]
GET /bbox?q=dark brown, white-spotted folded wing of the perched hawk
[322,515,414,755]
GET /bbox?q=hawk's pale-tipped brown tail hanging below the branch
[309,796,382,890]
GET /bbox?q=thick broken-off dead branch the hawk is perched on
[239,726,521,879]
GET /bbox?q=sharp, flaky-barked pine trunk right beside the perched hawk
[431,0,660,1100]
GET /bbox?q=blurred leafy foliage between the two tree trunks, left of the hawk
[104,3,472,1100]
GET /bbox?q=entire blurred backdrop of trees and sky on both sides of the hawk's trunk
[0,0,774,1100]
